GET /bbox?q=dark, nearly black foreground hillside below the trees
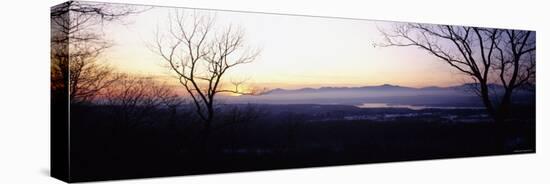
[70,104,535,182]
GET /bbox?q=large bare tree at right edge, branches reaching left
[379,24,536,122]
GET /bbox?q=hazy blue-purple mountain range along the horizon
[224,83,532,106]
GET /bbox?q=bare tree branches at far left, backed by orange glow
[50,1,144,104]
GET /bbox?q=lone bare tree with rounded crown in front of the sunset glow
[153,10,259,136]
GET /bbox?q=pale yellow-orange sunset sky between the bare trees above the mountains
[98,3,464,89]
